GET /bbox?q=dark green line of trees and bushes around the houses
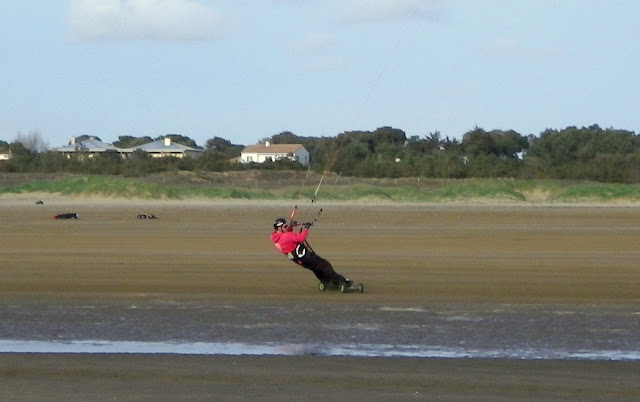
[0,125,640,183]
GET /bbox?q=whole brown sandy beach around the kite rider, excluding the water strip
[0,194,640,400]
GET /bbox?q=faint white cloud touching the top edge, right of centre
[338,0,444,23]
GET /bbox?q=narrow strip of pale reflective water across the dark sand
[0,339,640,364]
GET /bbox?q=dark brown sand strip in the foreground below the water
[5,355,640,401]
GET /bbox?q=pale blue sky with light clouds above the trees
[0,0,640,148]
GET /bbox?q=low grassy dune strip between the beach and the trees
[0,172,640,203]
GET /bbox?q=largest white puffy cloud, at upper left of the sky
[68,0,222,41]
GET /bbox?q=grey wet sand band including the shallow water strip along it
[0,300,640,360]
